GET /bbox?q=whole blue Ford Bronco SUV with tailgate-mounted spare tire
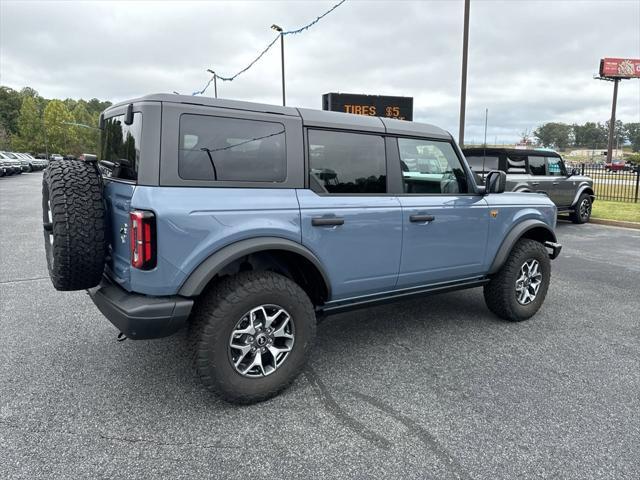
[42,94,561,403]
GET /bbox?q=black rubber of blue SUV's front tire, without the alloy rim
[484,238,551,322]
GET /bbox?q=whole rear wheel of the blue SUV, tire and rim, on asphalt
[189,272,316,404]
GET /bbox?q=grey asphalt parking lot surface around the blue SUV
[0,173,640,479]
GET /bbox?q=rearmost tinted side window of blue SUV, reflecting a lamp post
[178,114,286,182]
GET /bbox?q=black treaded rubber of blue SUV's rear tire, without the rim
[188,271,316,405]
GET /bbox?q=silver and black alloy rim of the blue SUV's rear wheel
[229,304,295,377]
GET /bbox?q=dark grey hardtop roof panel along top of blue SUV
[105,93,452,140]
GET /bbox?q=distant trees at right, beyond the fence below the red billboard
[533,120,640,152]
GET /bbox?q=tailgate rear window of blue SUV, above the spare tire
[100,112,142,181]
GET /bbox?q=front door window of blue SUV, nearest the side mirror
[398,138,468,194]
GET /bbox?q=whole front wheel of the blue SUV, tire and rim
[484,238,551,322]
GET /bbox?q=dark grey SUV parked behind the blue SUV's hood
[463,148,596,223]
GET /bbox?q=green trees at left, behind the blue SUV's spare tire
[0,86,111,155]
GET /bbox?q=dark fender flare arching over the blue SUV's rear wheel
[178,237,331,298]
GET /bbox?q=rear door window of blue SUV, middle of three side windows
[308,130,387,193]
